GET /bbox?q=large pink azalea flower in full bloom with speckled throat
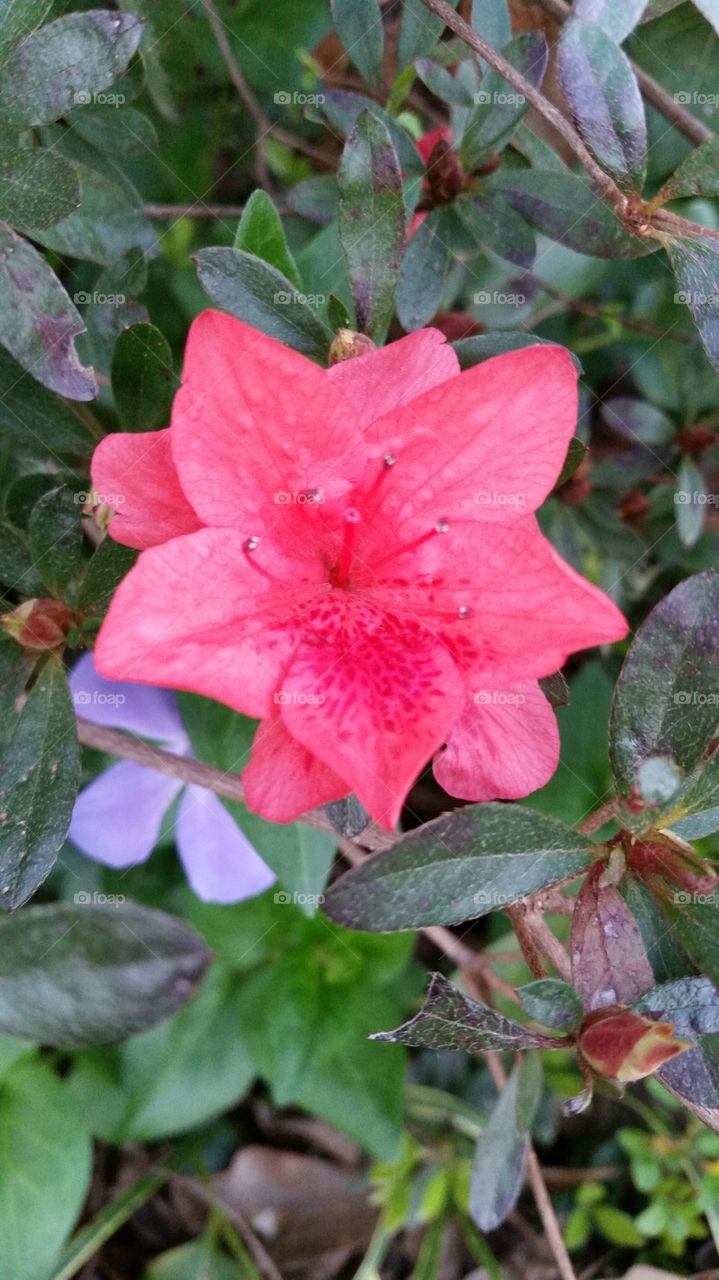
[92,311,627,827]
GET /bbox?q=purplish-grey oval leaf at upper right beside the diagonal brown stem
[557,19,646,193]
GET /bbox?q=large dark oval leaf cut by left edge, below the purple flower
[0,892,209,1046]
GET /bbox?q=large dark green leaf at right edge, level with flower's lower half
[609,572,719,829]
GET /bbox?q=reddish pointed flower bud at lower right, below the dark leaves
[577,1005,691,1084]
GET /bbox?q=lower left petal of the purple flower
[69,760,182,868]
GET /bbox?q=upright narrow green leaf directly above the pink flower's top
[338,111,406,343]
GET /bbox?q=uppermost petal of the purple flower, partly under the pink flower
[69,653,189,753]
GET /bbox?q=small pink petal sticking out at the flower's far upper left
[92,430,202,550]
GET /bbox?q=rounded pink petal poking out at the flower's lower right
[434,681,559,800]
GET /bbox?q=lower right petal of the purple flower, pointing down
[175,786,275,902]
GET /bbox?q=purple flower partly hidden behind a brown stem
[69,654,275,902]
